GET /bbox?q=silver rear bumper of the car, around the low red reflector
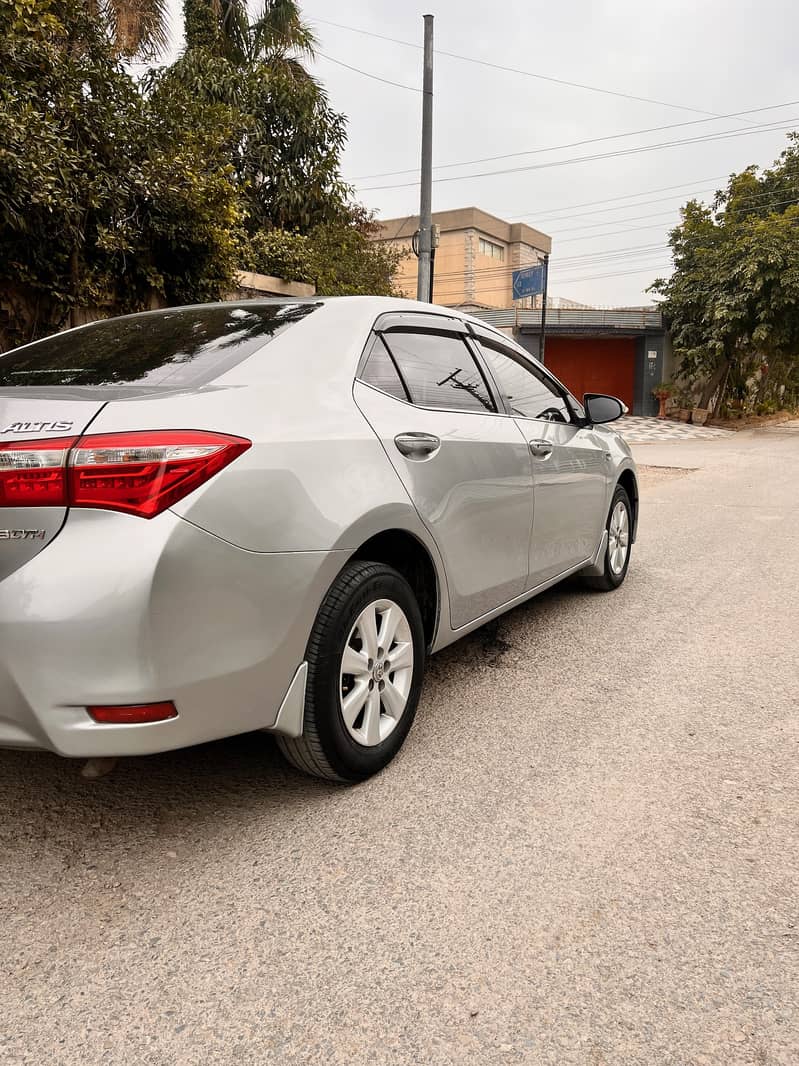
[0,511,347,758]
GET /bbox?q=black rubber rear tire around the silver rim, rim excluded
[277,562,425,782]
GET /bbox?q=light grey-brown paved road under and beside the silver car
[0,424,799,1066]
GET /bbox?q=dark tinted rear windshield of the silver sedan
[0,303,320,388]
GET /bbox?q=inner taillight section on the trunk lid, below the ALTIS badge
[0,437,78,507]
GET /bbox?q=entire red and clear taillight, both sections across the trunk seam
[0,430,251,518]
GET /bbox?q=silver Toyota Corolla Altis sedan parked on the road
[0,297,638,781]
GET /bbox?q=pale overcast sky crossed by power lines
[159,0,799,306]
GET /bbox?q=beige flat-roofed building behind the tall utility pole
[374,207,552,310]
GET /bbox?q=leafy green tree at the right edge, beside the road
[653,134,799,407]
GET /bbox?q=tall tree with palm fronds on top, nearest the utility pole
[162,0,350,233]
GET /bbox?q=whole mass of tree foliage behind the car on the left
[0,0,394,350]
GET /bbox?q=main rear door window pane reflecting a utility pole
[384,332,495,411]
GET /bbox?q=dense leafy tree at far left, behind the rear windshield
[0,0,242,346]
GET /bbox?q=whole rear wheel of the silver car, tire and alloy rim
[277,562,425,781]
